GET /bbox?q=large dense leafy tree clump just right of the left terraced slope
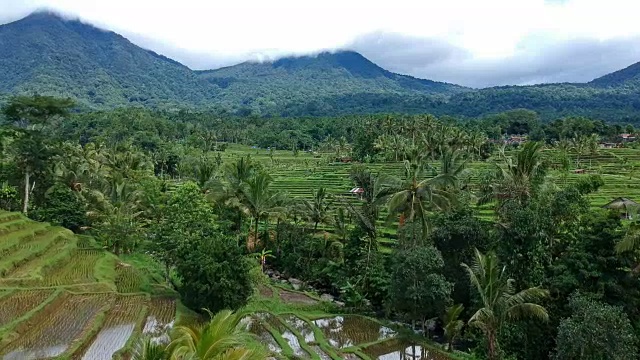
[166,183,252,311]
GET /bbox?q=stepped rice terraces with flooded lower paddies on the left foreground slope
[0,211,176,360]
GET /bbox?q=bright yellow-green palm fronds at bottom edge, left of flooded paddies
[168,310,267,360]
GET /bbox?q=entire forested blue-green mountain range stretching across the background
[0,12,640,122]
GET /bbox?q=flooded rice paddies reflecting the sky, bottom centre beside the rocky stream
[245,287,451,360]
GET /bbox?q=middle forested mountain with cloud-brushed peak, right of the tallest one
[199,51,470,114]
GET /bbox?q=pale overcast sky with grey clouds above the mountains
[0,0,640,87]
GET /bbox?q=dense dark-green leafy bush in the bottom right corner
[554,293,638,360]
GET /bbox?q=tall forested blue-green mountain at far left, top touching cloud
[0,12,215,107]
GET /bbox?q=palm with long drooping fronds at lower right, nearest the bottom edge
[462,249,549,360]
